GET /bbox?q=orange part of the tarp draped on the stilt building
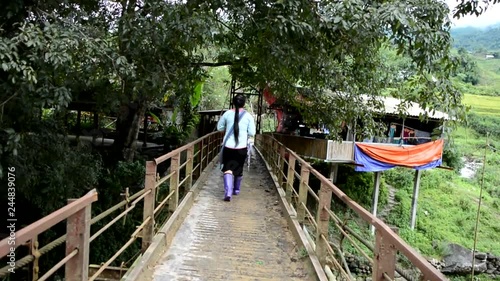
[356,139,444,167]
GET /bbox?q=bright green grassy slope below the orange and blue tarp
[386,155,500,258]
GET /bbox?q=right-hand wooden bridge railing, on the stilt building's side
[256,134,447,280]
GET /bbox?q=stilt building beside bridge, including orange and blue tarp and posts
[264,89,449,230]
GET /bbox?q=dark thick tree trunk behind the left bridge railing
[113,101,146,162]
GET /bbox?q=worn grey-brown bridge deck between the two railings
[152,154,315,281]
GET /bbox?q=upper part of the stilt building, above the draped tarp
[266,94,449,164]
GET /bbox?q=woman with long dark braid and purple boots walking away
[217,94,255,201]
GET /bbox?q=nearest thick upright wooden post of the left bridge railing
[64,199,92,281]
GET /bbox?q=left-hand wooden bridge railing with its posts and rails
[0,132,222,281]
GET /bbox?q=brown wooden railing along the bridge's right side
[256,134,447,281]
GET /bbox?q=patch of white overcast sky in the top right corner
[446,0,500,27]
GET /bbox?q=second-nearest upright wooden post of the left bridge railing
[141,161,156,253]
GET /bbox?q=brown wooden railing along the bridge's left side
[0,132,222,281]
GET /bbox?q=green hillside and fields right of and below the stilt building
[376,26,500,280]
